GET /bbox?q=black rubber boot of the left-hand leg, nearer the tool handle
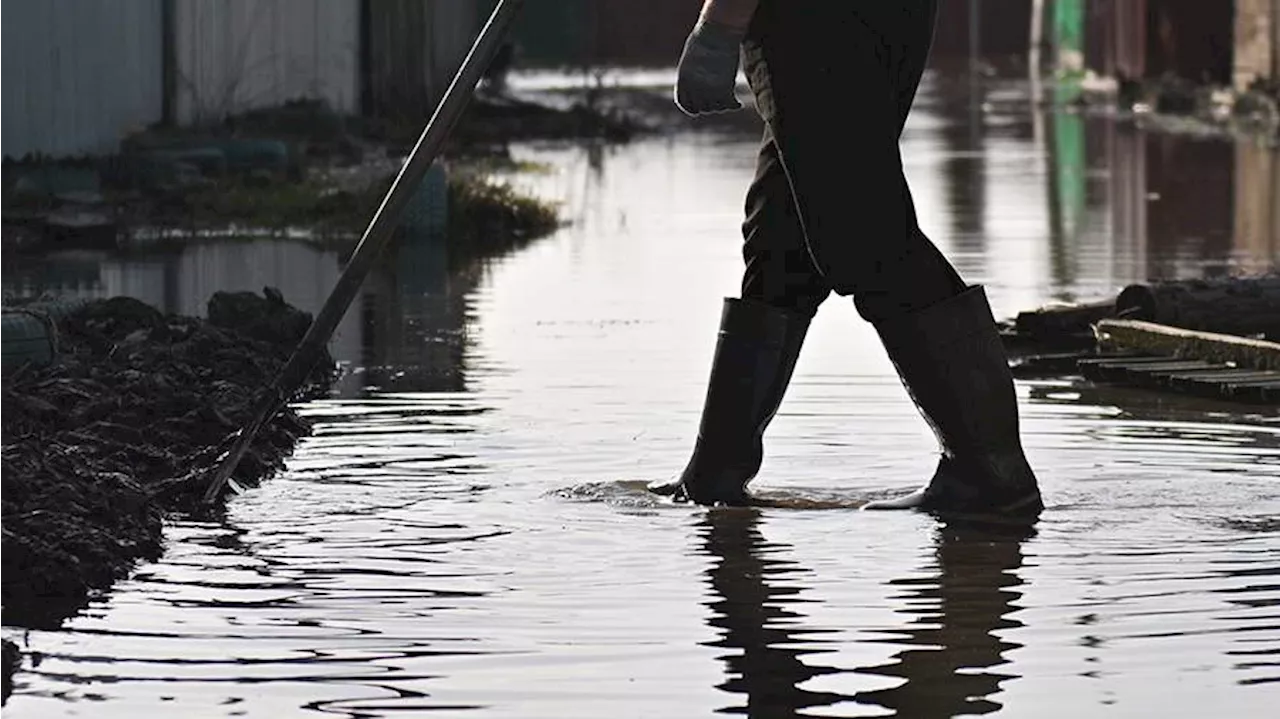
[649,298,809,504]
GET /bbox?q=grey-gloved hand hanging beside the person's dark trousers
[676,18,746,116]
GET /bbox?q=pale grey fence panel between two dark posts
[173,0,360,123]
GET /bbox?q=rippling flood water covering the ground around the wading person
[3,75,1280,719]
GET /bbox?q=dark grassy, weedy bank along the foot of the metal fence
[0,101,570,266]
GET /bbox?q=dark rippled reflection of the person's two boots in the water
[699,509,1025,719]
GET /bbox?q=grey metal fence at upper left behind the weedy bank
[0,0,478,157]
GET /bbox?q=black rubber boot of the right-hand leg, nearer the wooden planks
[865,287,1044,522]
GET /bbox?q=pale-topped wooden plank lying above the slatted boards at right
[1094,320,1280,370]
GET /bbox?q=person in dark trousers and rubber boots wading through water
[650,0,1043,522]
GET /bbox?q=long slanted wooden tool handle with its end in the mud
[205,0,524,504]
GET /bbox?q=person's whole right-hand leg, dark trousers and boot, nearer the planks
[744,0,1043,517]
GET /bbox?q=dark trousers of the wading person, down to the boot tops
[742,0,965,322]
